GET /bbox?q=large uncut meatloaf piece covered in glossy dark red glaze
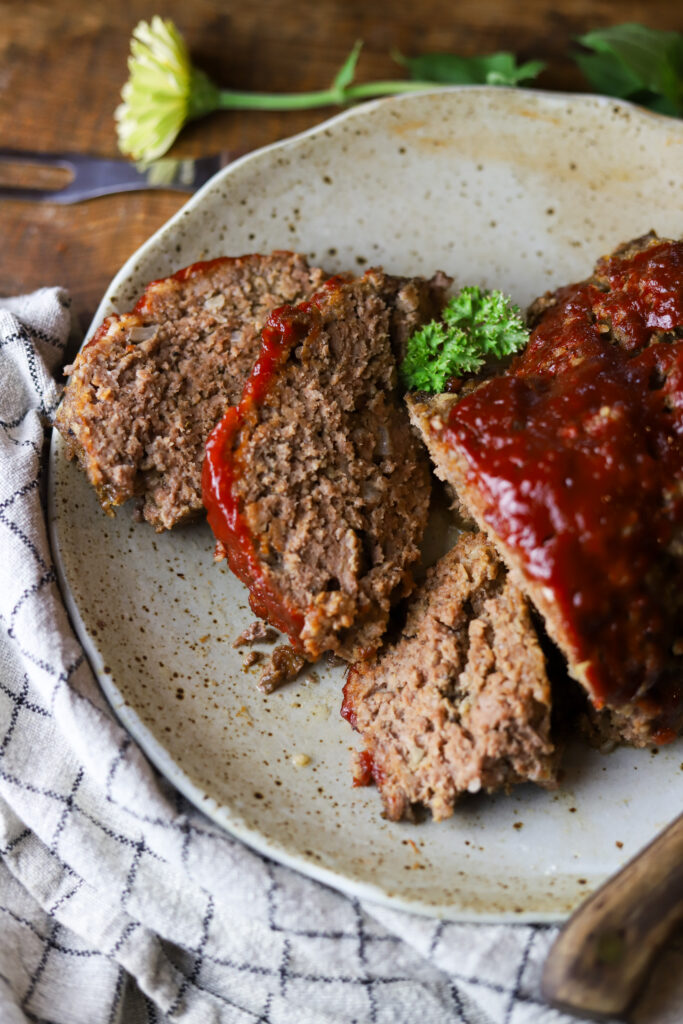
[409,236,683,745]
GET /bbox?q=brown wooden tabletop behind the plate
[0,0,683,330]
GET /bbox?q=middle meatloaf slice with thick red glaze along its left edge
[204,270,446,660]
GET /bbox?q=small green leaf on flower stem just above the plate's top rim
[393,53,546,85]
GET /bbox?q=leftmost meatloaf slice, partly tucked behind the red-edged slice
[55,252,326,530]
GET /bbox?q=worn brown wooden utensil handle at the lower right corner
[542,815,683,1020]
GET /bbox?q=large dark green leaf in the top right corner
[574,23,683,117]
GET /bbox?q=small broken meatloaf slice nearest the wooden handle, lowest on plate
[342,534,555,820]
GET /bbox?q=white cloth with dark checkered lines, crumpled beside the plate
[0,289,671,1024]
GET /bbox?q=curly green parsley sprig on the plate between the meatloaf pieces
[400,286,529,393]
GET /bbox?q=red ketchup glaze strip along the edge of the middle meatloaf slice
[202,276,346,649]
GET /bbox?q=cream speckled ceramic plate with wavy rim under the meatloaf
[50,88,683,921]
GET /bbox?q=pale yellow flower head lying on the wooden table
[115,14,217,163]
